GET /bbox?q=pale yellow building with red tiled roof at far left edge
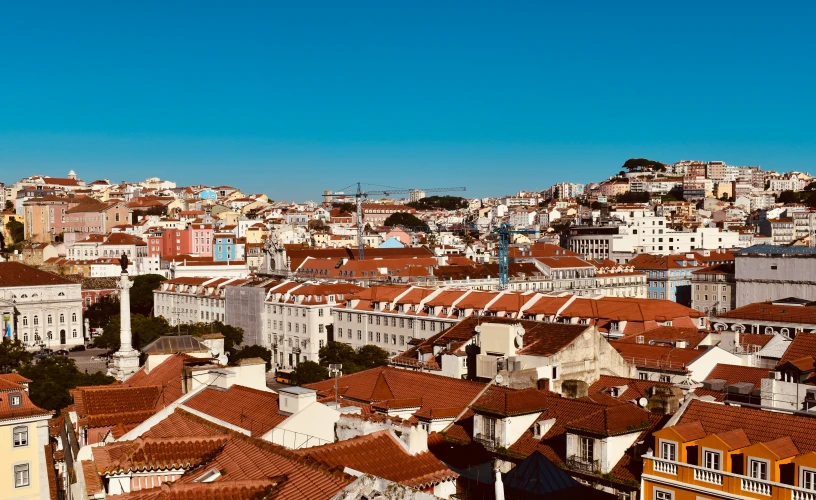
[0,373,56,500]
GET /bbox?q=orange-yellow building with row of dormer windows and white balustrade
[641,400,816,500]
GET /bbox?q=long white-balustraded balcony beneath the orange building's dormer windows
[643,454,816,500]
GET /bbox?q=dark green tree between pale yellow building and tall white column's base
[20,356,116,411]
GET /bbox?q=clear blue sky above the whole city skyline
[0,1,816,200]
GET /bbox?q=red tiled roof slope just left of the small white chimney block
[184,385,288,437]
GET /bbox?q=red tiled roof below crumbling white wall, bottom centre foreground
[297,430,458,489]
